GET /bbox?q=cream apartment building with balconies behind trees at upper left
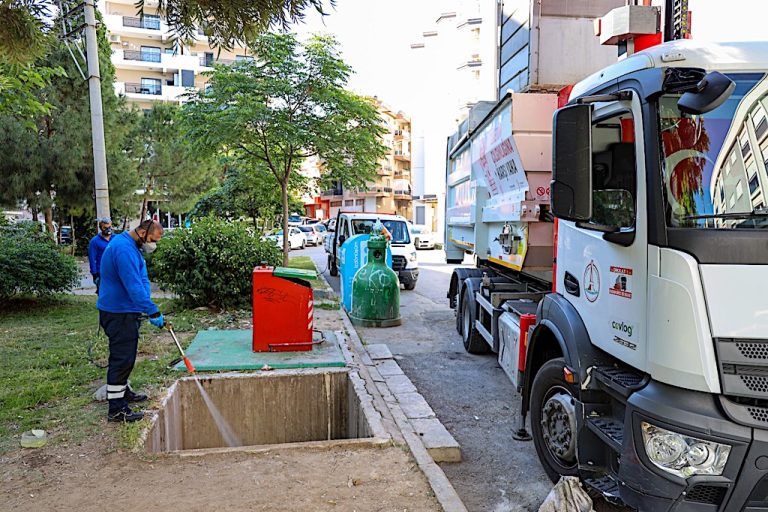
[98,0,252,109]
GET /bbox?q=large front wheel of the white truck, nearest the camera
[531,357,578,483]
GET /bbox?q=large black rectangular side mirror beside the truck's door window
[551,104,592,221]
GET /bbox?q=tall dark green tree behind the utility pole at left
[0,4,138,231]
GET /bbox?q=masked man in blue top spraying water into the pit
[96,220,165,422]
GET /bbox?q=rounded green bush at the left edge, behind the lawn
[0,222,80,300]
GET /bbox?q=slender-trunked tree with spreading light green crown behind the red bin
[184,34,384,265]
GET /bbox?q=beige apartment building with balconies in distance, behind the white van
[305,100,413,219]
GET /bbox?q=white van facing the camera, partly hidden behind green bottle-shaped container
[325,212,419,290]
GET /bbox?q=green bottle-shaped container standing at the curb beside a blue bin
[349,235,402,327]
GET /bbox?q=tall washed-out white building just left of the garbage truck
[411,0,498,238]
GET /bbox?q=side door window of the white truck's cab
[583,112,637,229]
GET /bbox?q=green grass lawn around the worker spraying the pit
[0,295,250,453]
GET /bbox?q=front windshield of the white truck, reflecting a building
[659,73,768,229]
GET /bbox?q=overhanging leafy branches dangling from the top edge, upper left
[0,0,334,63]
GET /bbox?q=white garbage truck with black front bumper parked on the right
[445,40,768,512]
